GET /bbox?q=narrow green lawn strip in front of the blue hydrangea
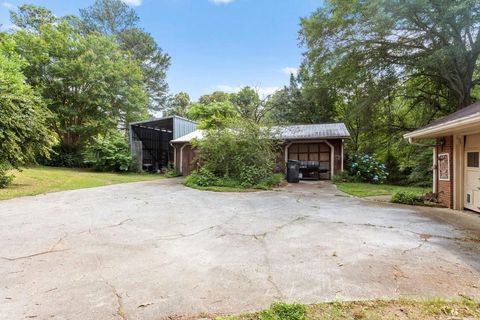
[336,182,431,197]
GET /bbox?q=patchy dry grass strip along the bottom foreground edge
[218,298,480,320]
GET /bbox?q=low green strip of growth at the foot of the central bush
[184,173,285,192]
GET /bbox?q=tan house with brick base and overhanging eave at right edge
[404,102,480,212]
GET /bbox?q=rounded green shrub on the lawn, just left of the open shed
[84,131,133,171]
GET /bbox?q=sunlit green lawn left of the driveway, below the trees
[0,166,163,200]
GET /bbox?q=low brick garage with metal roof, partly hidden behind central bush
[171,123,350,179]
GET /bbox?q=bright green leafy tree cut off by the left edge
[0,33,57,188]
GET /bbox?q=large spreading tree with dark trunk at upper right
[301,0,480,111]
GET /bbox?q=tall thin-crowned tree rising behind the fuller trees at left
[80,0,170,111]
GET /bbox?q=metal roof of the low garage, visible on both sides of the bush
[172,123,350,143]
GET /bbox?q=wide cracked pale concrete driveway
[0,179,480,320]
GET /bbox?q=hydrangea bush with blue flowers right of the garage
[349,154,388,183]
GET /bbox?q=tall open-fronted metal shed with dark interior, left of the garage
[130,116,197,171]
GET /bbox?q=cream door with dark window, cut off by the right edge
[464,134,480,212]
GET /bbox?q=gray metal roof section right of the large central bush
[273,123,350,140]
